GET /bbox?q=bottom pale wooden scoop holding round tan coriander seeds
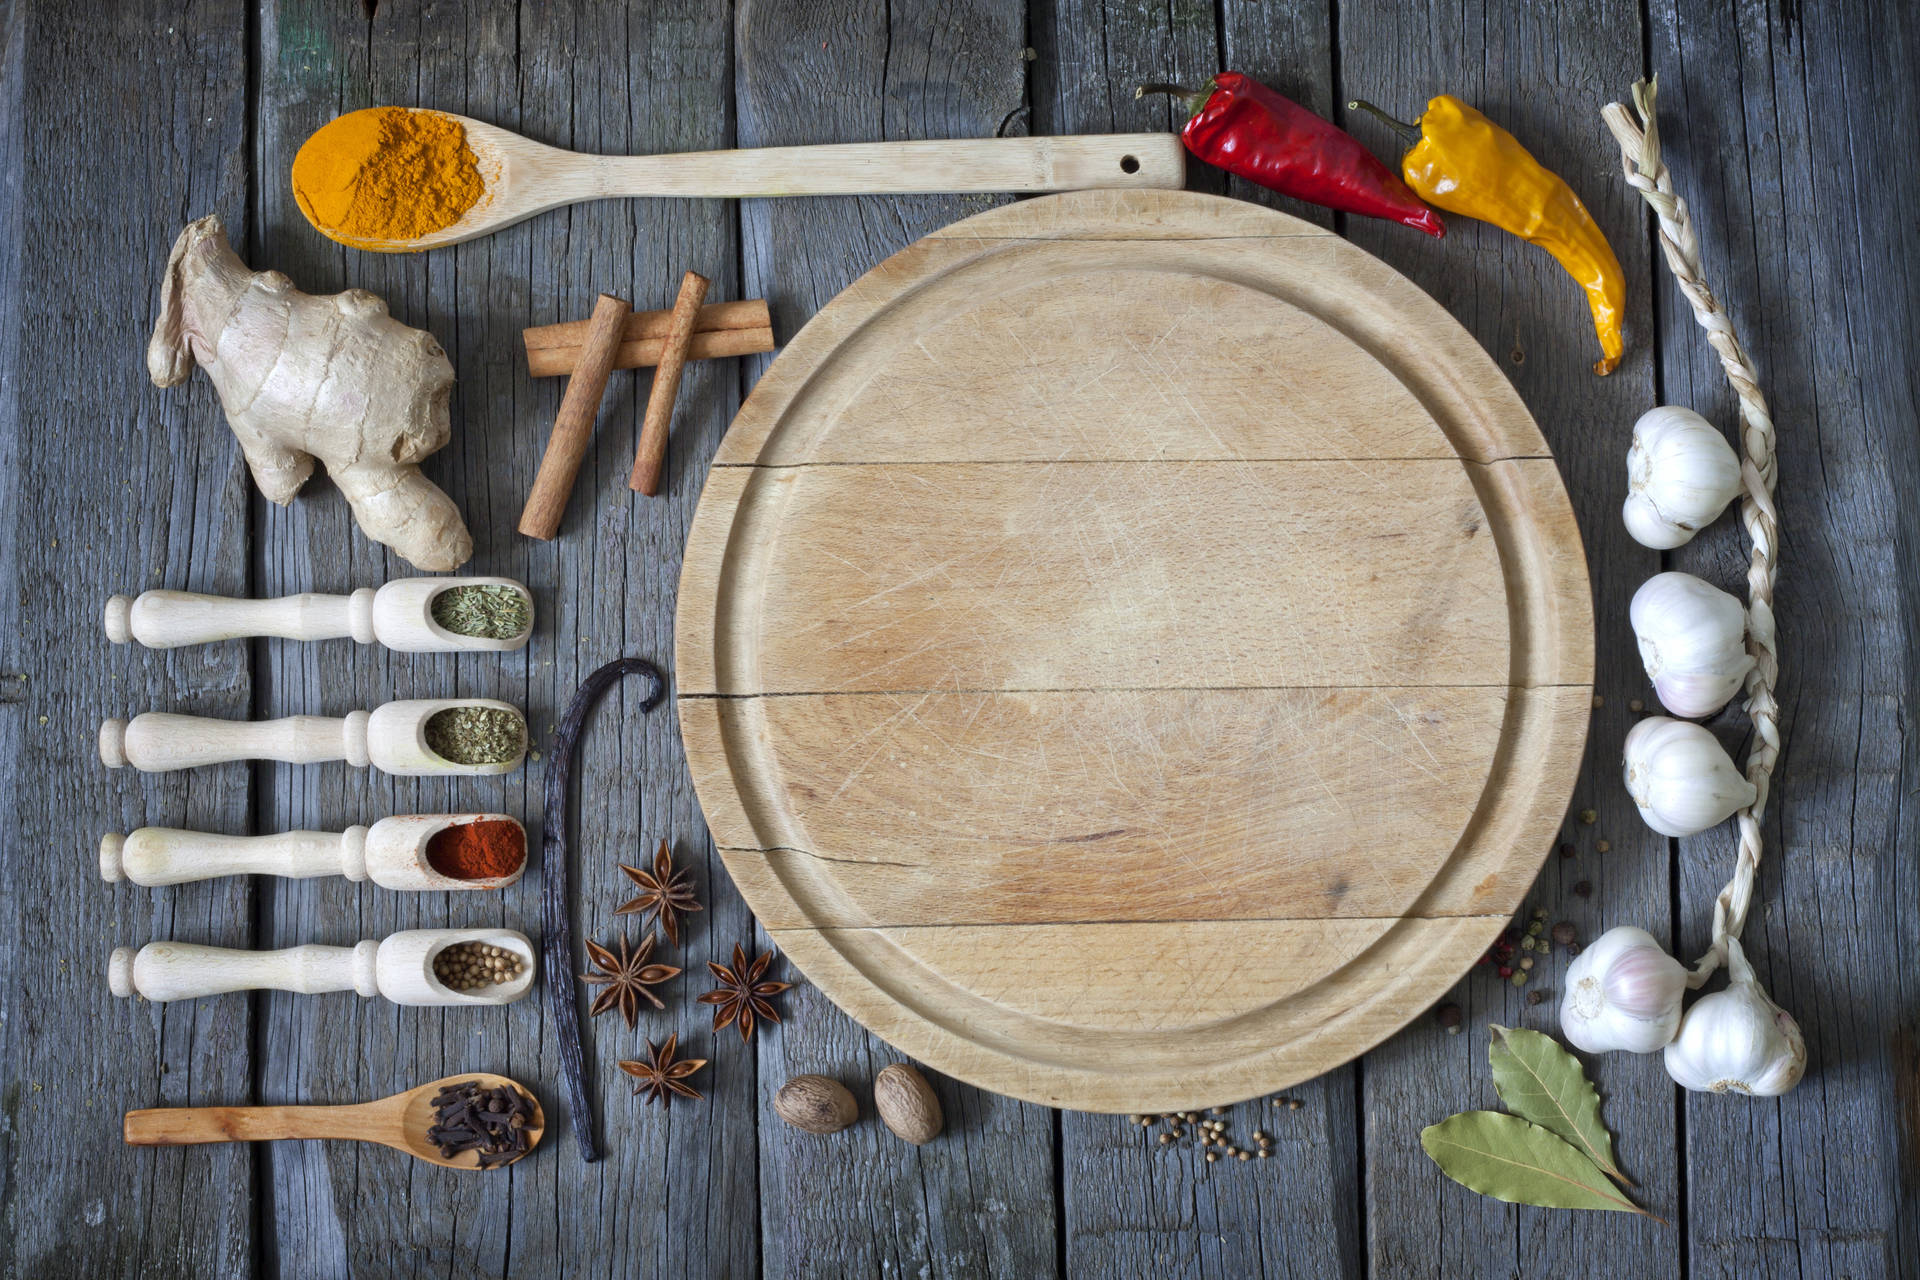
[108,929,534,1006]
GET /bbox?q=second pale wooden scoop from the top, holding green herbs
[100,699,526,777]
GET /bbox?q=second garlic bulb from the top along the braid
[1626,574,1753,720]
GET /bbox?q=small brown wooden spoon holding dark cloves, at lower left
[123,1071,547,1169]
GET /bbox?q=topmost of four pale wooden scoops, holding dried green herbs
[106,578,534,652]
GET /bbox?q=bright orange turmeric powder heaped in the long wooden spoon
[294,107,486,248]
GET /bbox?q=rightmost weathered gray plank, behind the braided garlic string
[1651,0,1920,1278]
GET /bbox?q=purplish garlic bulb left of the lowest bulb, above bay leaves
[1561,925,1686,1054]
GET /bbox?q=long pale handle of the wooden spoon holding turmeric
[593,132,1187,196]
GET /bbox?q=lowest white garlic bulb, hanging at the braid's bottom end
[1667,938,1807,1098]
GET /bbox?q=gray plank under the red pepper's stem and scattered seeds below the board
[1031,0,1361,1276]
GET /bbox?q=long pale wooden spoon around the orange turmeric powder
[301,107,1187,253]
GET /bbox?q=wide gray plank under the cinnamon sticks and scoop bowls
[261,0,758,1276]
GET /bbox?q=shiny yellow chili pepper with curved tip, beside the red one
[1348,94,1626,374]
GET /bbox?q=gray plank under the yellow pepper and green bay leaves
[1338,0,1680,1276]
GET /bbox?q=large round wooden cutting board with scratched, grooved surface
[676,192,1594,1111]
